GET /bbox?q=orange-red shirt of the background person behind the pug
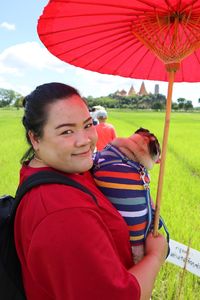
[95,123,116,151]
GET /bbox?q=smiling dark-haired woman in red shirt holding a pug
[15,83,167,300]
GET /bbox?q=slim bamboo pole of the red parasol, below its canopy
[153,70,175,236]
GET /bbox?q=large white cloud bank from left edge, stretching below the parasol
[0,42,200,106]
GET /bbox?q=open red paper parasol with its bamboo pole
[38,0,200,234]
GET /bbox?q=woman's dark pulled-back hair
[20,82,80,164]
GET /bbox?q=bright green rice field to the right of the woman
[109,111,200,300]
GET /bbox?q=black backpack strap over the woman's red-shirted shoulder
[12,171,98,215]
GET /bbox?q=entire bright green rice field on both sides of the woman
[0,109,200,300]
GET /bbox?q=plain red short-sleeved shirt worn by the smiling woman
[15,166,140,300]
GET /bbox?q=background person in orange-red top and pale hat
[96,110,117,151]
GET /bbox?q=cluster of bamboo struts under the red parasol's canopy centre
[132,0,200,63]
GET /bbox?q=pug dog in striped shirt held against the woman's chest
[92,128,168,263]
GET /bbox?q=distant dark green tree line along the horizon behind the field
[0,88,200,111]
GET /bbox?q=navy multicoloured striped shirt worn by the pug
[92,145,152,245]
